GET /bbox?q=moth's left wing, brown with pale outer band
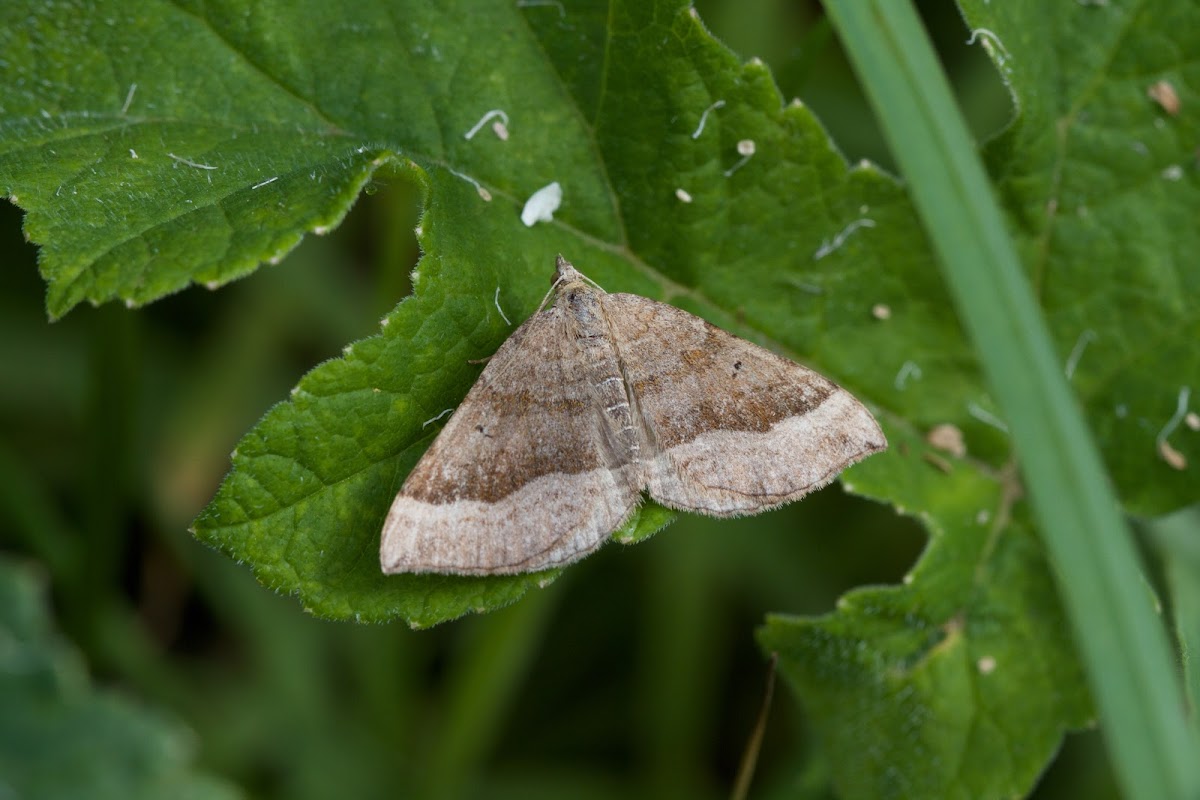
[379,308,638,575]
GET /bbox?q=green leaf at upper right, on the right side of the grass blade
[961,0,1200,515]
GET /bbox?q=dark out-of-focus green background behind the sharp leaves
[0,0,1116,798]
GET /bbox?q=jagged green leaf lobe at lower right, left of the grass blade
[758,429,1093,798]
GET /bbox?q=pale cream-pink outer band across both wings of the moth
[382,390,877,575]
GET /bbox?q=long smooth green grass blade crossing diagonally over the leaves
[826,0,1200,798]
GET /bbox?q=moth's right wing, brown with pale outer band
[604,294,887,517]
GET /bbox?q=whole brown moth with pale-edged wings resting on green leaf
[379,255,887,575]
